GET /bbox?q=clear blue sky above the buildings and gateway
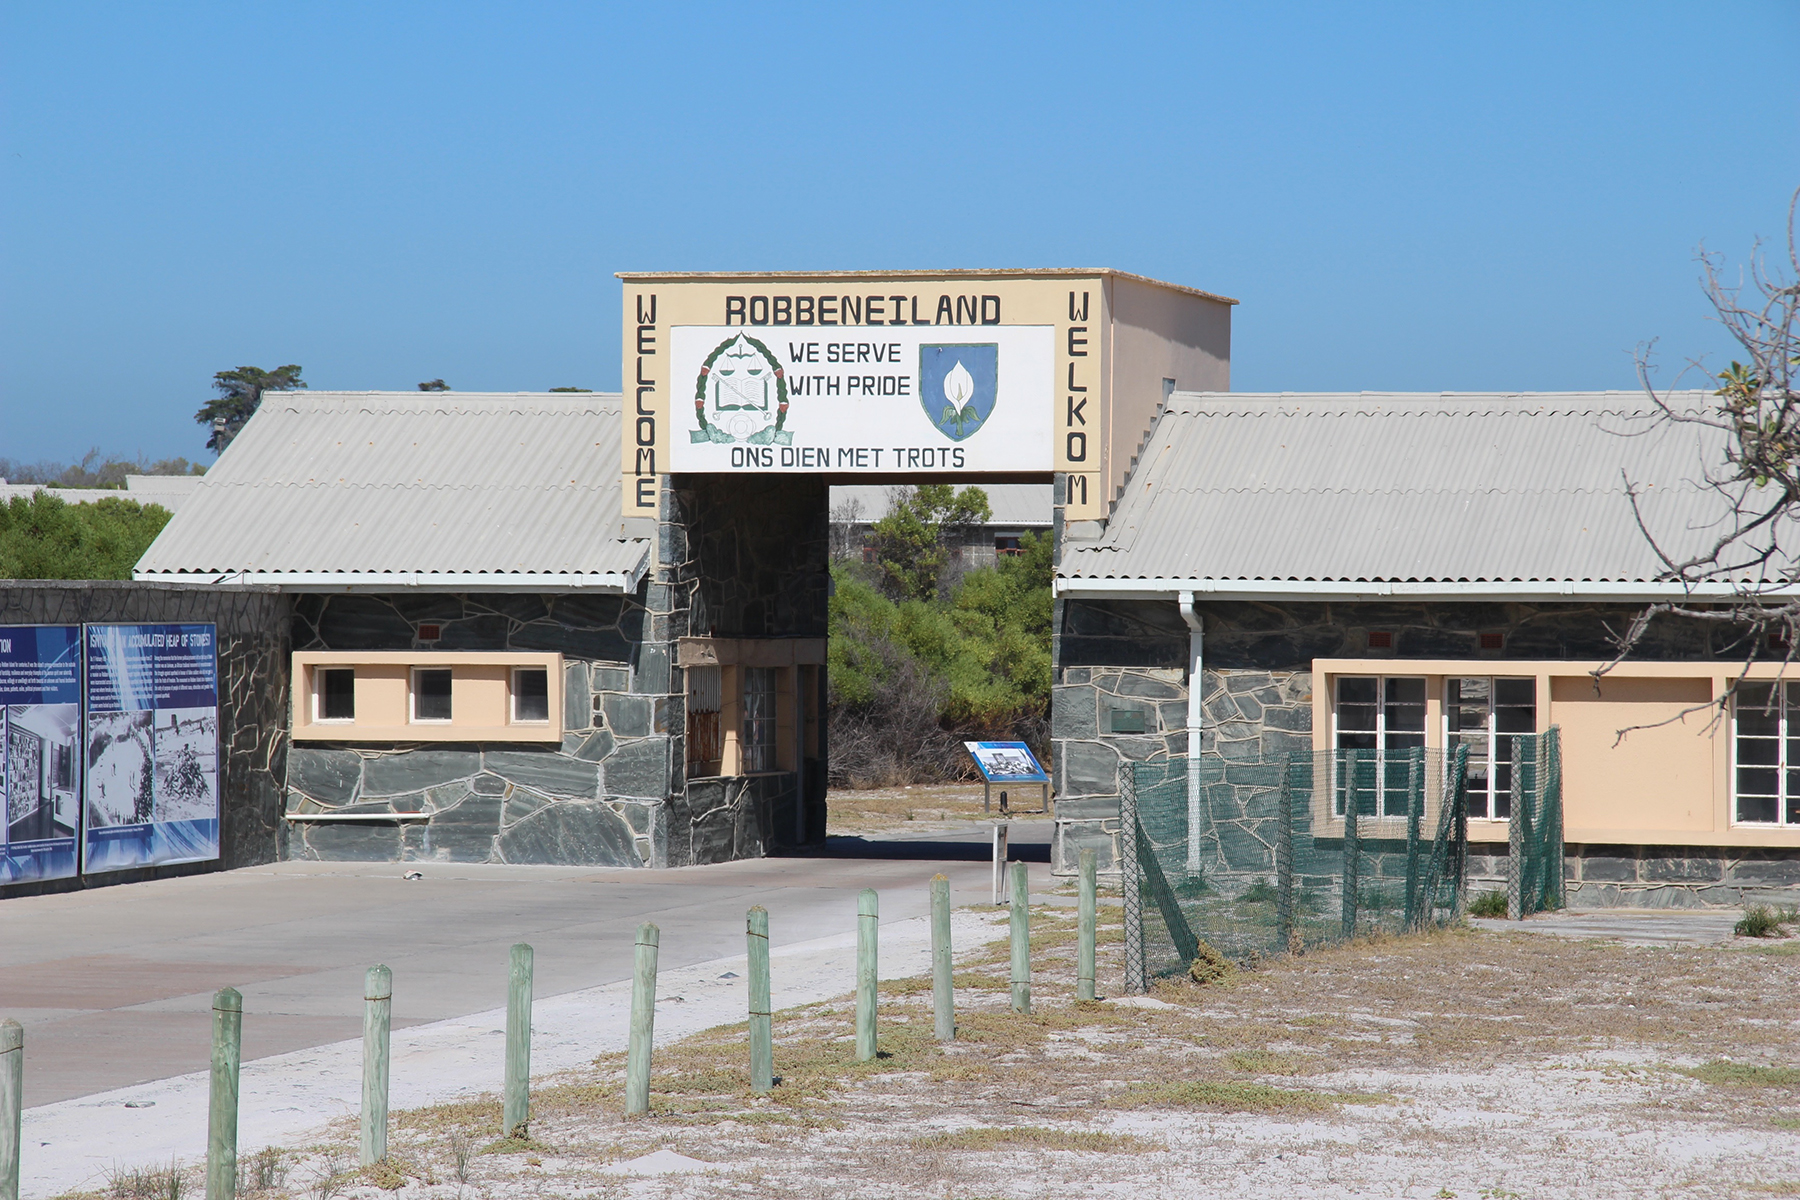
[0,0,1800,461]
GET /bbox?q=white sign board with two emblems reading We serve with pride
[670,326,1057,473]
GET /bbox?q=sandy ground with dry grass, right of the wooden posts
[63,892,1800,1200]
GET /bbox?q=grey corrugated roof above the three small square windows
[137,392,650,587]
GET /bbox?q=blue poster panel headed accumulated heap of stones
[81,624,220,873]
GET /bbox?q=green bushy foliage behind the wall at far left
[0,491,169,579]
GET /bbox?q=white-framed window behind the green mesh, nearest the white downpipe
[1332,675,1426,817]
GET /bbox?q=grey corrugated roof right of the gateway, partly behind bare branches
[1058,392,1793,581]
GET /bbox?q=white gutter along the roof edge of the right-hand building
[1055,578,1800,601]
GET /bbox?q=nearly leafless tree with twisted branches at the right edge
[1595,189,1800,720]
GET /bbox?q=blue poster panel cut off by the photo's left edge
[0,624,81,883]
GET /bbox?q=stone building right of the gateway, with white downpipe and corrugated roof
[1053,392,1800,905]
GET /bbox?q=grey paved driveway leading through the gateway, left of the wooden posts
[0,820,1051,1106]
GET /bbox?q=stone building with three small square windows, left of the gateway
[137,392,828,865]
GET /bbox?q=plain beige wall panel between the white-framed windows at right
[1550,676,1714,842]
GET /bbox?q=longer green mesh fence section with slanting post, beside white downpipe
[1121,747,1476,990]
